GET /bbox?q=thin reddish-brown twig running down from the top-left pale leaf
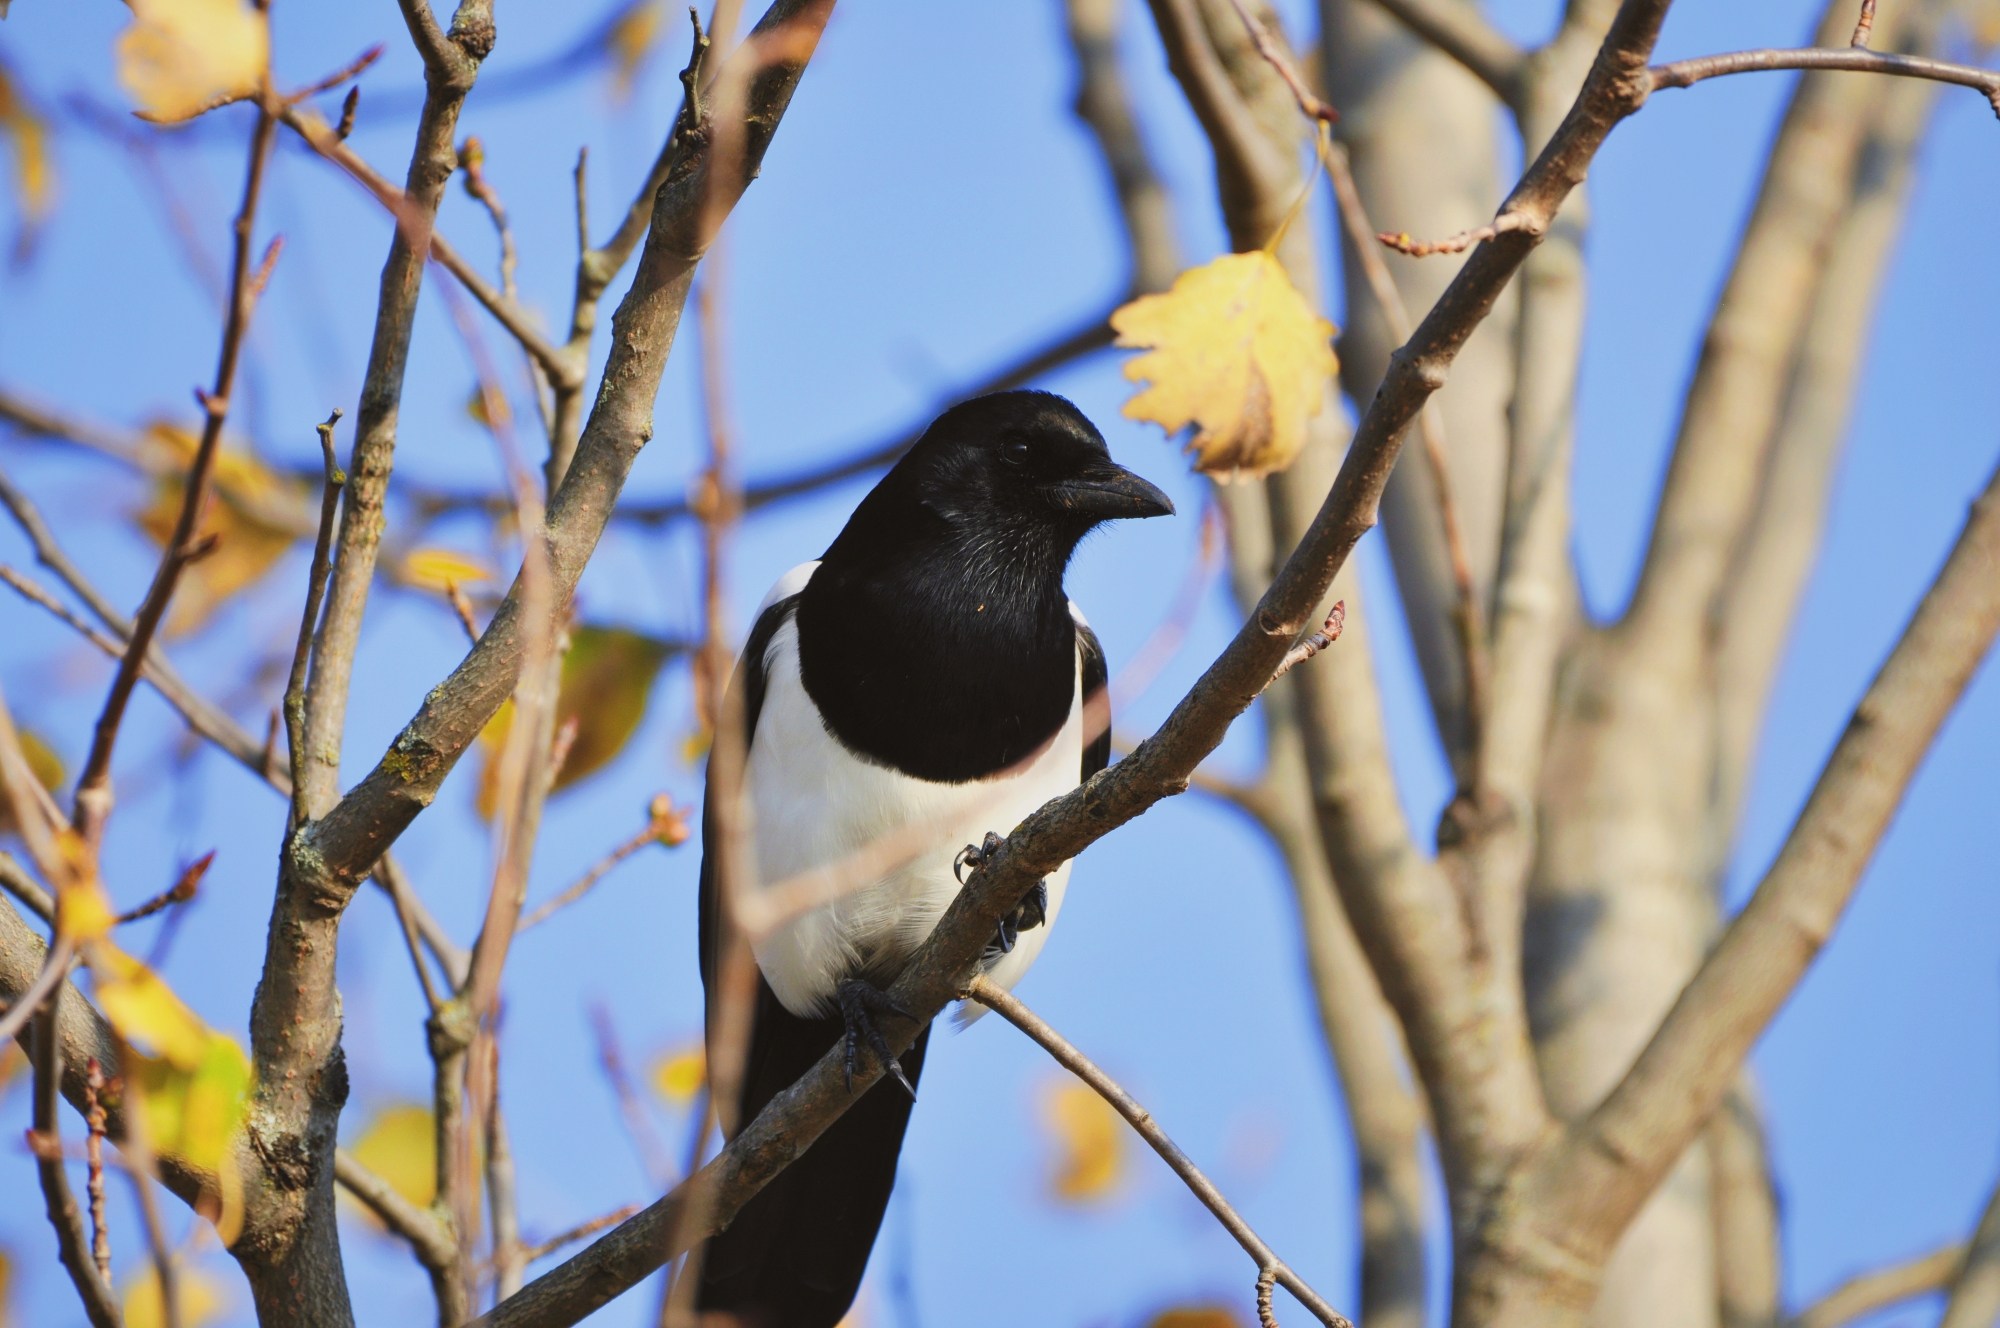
[74,102,278,844]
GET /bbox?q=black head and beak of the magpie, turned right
[894,392,1174,544]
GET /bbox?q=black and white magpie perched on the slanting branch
[696,390,1174,1328]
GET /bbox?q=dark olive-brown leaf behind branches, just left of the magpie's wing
[478,626,668,820]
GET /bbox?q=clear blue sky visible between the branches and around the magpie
[0,0,2000,1328]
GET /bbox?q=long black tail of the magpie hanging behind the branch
[696,974,930,1328]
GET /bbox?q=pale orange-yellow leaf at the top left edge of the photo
[118,0,270,120]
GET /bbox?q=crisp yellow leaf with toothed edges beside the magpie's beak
[1112,250,1338,478]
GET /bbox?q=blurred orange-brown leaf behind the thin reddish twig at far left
[136,422,306,636]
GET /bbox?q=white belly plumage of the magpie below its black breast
[746,622,1084,1016]
